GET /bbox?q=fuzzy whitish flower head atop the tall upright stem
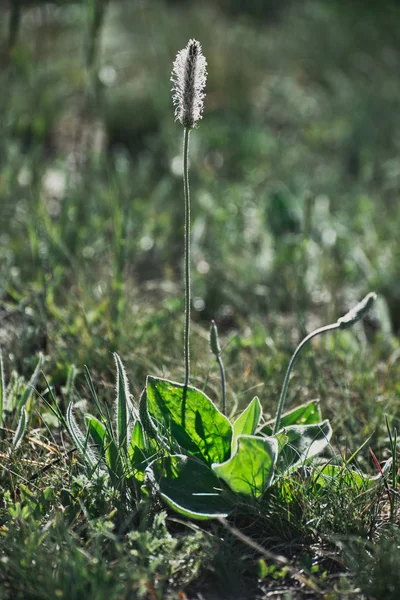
[171,40,207,129]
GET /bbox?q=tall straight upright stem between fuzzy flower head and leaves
[183,127,190,388]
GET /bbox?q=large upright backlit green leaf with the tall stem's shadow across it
[146,376,232,463]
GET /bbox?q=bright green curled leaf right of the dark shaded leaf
[212,435,278,498]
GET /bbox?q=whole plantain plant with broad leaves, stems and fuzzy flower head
[45,40,382,519]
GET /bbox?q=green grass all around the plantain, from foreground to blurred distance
[0,0,400,600]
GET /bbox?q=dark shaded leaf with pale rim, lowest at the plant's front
[147,454,232,519]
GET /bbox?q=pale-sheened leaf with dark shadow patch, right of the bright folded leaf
[277,420,332,472]
